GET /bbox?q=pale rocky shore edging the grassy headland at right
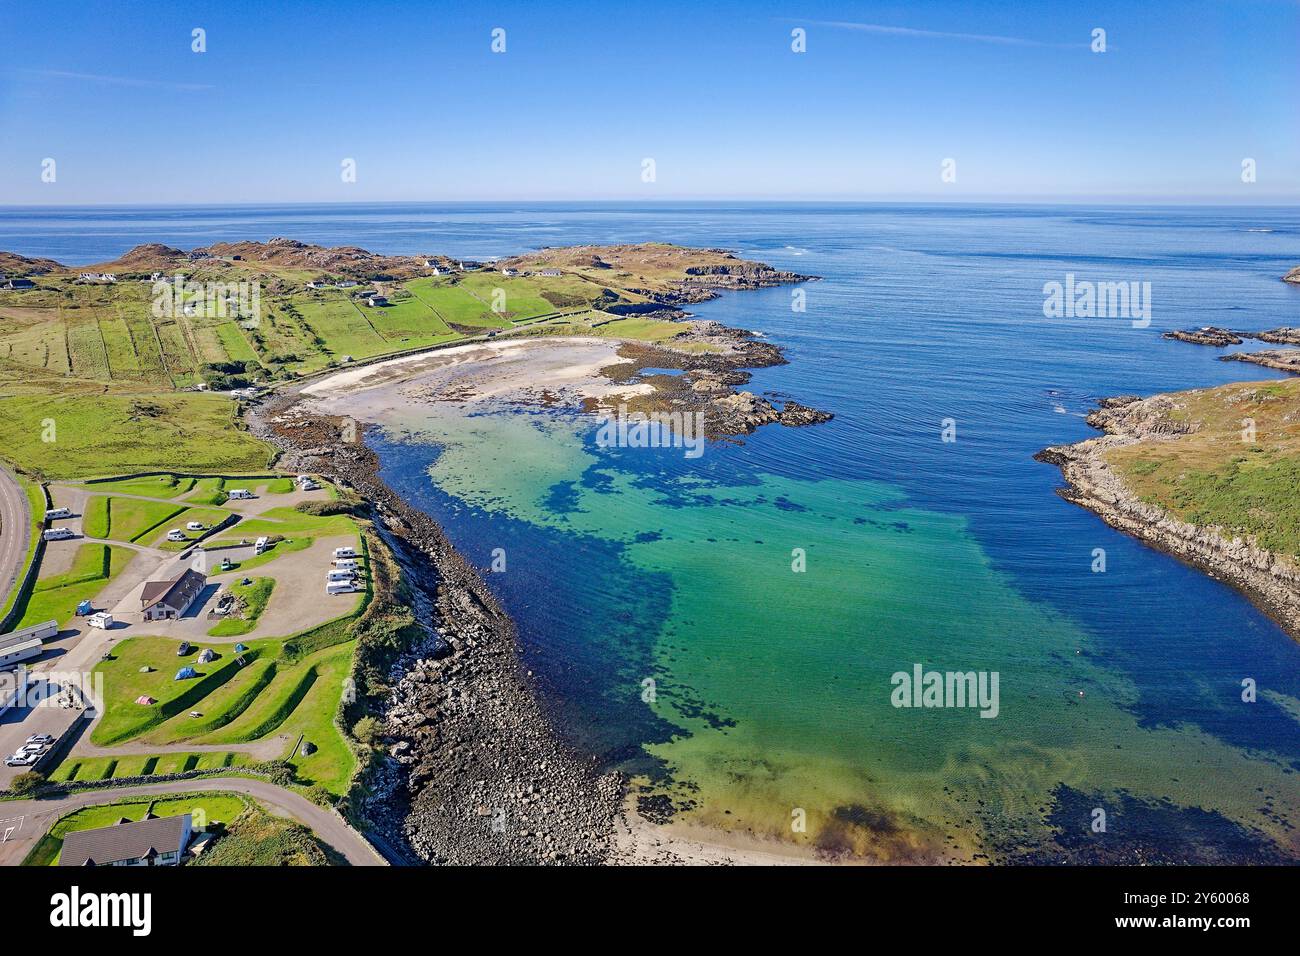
[1035,395,1300,640]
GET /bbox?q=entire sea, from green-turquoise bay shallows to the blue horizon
[10,204,1300,862]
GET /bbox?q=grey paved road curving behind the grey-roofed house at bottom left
[0,777,385,866]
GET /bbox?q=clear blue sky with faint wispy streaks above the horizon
[0,0,1300,204]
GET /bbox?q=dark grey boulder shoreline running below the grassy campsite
[248,395,624,865]
